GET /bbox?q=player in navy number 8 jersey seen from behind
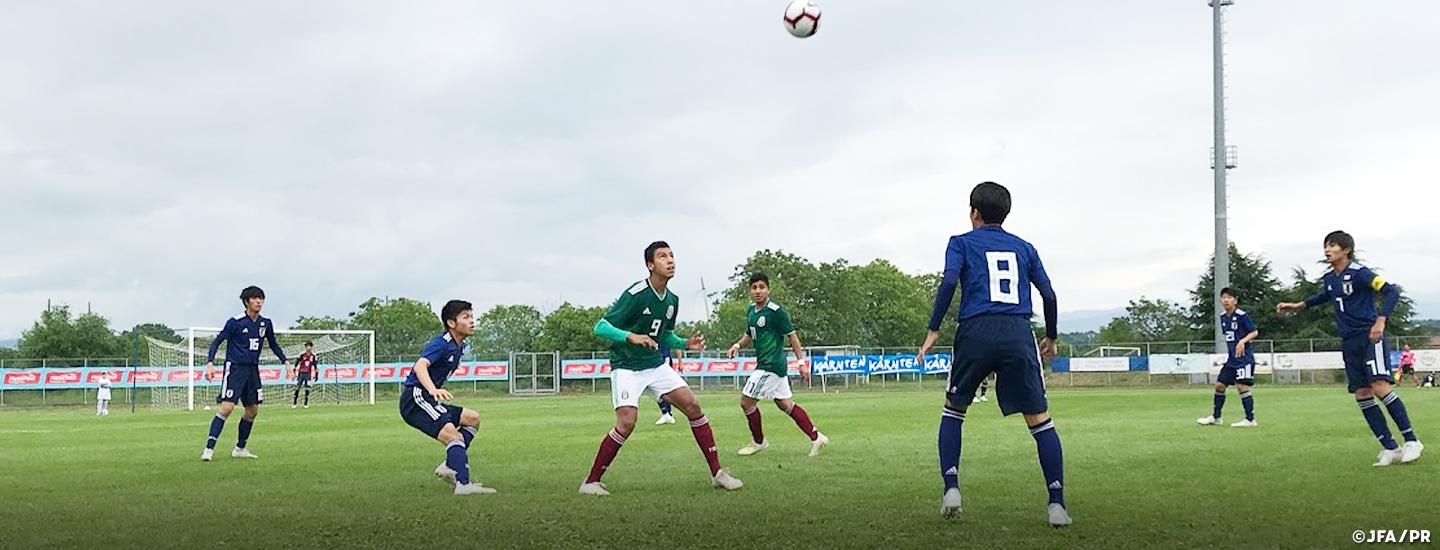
[917,181,1071,527]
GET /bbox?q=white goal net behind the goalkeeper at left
[145,328,374,410]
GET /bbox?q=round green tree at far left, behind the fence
[19,305,130,366]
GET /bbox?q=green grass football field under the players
[0,386,1440,549]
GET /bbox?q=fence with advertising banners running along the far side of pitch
[0,338,1440,406]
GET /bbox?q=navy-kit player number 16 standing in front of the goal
[200,287,289,461]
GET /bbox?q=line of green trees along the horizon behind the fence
[0,245,1440,366]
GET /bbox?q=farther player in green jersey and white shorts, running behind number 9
[729,272,829,456]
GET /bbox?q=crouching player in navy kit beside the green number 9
[400,299,495,495]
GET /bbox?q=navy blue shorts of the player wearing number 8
[945,315,1050,416]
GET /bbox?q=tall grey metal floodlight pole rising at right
[1210,0,1236,353]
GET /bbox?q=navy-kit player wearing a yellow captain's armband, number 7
[1276,230,1426,466]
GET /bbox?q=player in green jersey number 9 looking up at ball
[580,240,744,495]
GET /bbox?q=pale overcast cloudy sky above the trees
[0,0,1440,338]
